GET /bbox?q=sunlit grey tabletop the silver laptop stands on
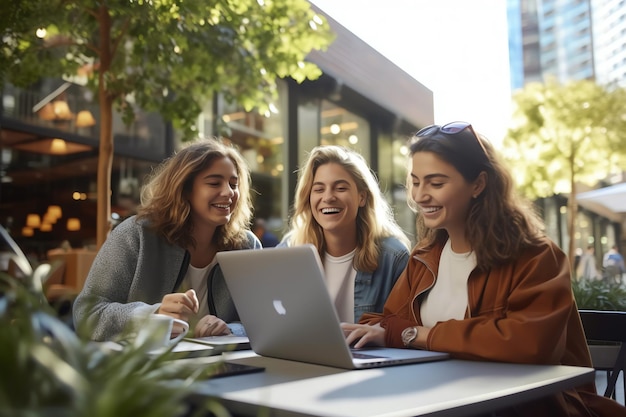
[185,351,594,417]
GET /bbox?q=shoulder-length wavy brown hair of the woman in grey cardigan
[137,139,252,250]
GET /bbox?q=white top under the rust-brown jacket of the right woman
[420,239,476,327]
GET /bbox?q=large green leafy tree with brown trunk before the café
[0,0,333,247]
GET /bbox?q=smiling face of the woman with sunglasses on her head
[410,152,485,245]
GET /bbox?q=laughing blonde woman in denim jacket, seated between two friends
[279,146,409,323]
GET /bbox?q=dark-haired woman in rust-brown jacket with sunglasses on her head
[342,122,626,417]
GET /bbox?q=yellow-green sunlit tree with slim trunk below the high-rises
[503,80,626,261]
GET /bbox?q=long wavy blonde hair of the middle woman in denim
[286,145,410,272]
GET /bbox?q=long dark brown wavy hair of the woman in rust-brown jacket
[407,128,545,270]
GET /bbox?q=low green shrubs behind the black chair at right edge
[572,279,626,311]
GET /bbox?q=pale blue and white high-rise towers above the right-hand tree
[508,0,626,90]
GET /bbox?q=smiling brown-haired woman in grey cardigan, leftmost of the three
[74,139,261,341]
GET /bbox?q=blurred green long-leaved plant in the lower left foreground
[0,271,227,417]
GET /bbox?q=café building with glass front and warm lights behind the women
[0,6,434,259]
